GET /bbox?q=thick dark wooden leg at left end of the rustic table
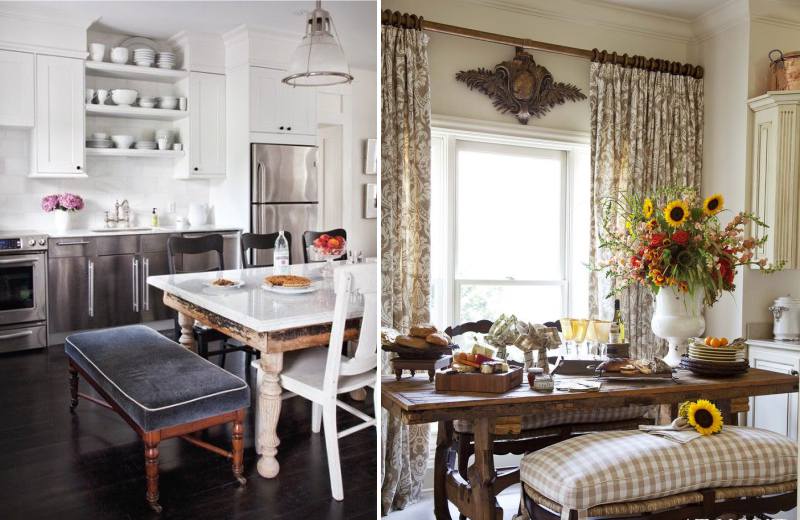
[469,417,503,520]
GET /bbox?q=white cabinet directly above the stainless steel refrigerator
[250,67,317,136]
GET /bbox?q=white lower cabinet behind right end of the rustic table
[747,340,800,440]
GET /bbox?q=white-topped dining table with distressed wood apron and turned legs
[147,263,363,478]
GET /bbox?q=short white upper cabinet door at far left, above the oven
[0,50,35,128]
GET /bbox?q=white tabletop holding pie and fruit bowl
[147,263,363,332]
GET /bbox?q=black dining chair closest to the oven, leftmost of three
[167,234,255,373]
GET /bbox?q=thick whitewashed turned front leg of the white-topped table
[256,352,283,478]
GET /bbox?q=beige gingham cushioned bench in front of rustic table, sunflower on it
[520,426,797,520]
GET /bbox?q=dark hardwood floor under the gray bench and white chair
[0,346,377,520]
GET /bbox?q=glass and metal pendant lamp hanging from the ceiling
[282,0,353,87]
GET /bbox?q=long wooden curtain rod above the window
[381,9,703,79]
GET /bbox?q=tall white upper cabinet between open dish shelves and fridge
[188,72,225,178]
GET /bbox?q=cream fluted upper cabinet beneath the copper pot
[749,91,800,269]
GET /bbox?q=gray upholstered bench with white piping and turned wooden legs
[64,325,250,512]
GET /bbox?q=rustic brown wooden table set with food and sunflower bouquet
[381,369,798,520]
